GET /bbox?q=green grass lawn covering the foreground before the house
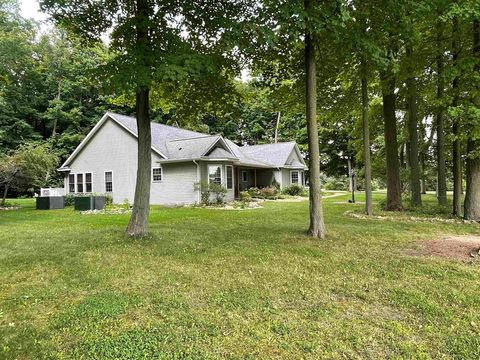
[0,194,480,359]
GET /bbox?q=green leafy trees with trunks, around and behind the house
[0,0,480,238]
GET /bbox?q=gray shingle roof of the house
[108,112,304,167]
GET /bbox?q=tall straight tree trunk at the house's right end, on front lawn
[304,0,326,239]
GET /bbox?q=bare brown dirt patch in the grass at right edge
[409,235,480,263]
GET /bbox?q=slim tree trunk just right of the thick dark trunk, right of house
[407,46,422,206]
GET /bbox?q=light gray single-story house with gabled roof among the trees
[58,112,306,205]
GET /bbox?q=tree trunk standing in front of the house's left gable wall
[126,88,152,236]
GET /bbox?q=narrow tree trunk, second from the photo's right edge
[452,18,462,217]
